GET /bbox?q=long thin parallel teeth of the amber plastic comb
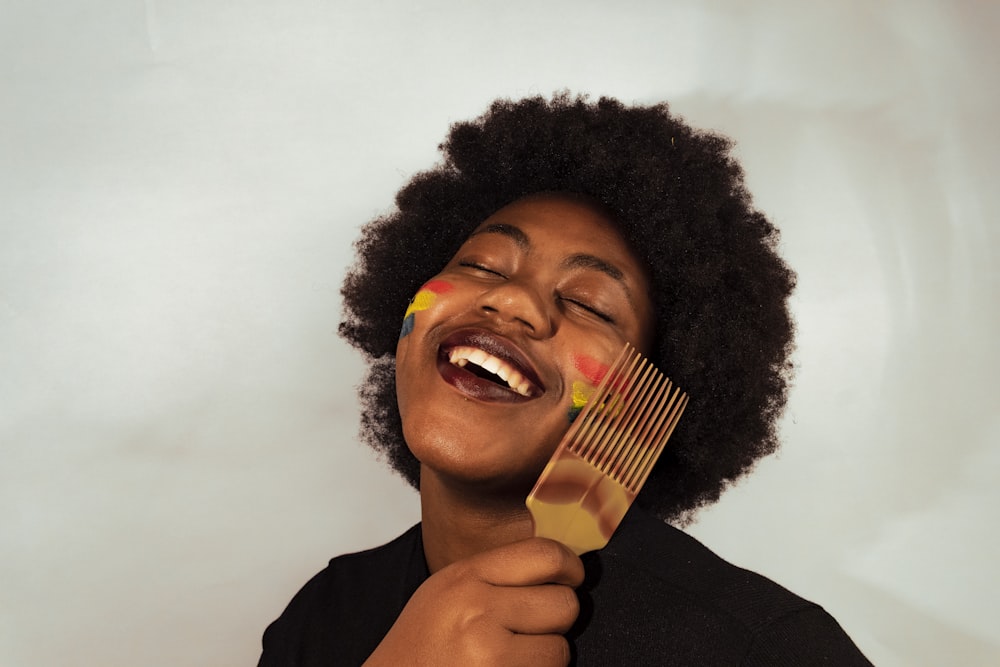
[564,344,687,494]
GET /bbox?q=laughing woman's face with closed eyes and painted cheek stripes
[396,195,653,497]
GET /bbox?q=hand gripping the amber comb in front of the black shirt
[365,537,584,667]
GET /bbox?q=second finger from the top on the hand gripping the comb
[490,584,580,635]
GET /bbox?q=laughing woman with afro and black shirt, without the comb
[260,95,869,665]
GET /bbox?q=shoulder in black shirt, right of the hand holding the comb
[581,508,868,665]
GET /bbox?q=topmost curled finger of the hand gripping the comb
[468,537,584,588]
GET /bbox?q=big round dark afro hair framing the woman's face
[340,93,795,523]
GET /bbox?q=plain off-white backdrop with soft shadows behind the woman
[0,0,1000,667]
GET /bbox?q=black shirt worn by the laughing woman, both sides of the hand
[258,508,871,667]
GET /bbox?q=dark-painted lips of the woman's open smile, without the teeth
[437,329,545,403]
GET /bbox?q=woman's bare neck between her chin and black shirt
[420,467,532,574]
